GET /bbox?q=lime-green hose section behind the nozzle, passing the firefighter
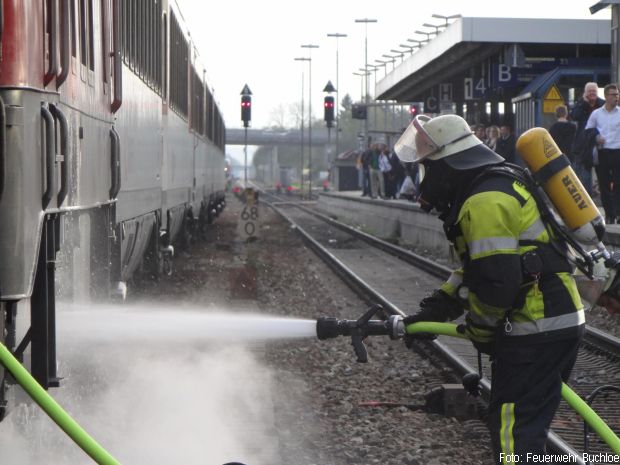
[405,322,620,454]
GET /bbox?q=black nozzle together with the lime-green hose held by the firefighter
[316,305,620,454]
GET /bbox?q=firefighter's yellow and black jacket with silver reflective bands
[442,176,584,342]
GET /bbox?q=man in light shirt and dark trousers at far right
[586,84,620,224]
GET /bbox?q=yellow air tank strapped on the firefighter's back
[517,128,605,245]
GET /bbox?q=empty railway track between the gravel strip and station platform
[262,189,620,463]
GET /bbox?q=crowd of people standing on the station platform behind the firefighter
[358,82,620,224]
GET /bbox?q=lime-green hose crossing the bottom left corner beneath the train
[0,342,120,465]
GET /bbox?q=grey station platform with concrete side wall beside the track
[316,190,620,260]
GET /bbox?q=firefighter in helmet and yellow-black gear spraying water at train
[396,115,585,463]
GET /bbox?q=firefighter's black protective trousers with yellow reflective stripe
[488,336,581,464]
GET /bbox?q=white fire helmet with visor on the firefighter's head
[394,115,504,170]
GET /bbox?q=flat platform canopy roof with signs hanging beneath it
[375,17,611,118]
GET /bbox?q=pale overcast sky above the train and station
[176,0,610,161]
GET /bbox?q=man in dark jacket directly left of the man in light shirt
[570,82,605,197]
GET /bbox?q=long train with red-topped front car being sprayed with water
[0,0,226,418]
